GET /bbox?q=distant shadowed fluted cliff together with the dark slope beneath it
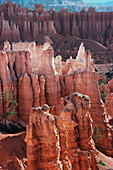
[0,1,113,64]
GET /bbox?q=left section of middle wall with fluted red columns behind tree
[0,45,60,122]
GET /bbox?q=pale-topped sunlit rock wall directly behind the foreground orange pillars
[0,42,113,156]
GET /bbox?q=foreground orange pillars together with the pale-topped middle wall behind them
[0,42,113,169]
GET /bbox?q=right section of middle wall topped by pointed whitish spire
[56,44,113,156]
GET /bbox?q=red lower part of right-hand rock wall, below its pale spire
[65,72,113,156]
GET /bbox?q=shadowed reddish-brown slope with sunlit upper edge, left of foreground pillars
[0,132,26,169]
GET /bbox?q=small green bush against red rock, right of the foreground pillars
[92,126,102,142]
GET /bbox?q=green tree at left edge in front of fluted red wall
[1,91,18,126]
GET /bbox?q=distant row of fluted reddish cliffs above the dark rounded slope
[0,1,113,47]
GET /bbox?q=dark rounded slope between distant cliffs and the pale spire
[50,34,113,63]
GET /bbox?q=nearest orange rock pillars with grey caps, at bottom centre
[27,93,98,170]
